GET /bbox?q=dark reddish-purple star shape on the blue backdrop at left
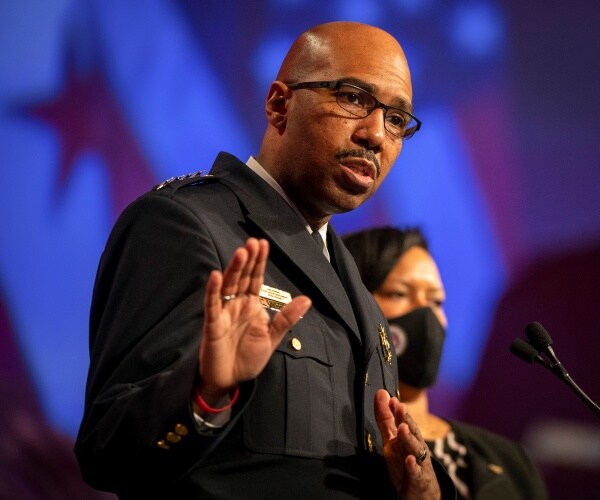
[31,68,156,216]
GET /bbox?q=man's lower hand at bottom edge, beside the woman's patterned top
[375,389,441,500]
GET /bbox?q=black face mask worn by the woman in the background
[388,307,446,389]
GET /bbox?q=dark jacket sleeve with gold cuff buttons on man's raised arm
[75,193,244,491]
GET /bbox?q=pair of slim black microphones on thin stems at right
[510,321,600,418]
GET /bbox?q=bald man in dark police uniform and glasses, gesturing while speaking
[76,22,453,498]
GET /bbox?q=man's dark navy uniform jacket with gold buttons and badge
[76,153,454,499]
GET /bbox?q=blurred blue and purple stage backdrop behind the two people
[0,0,600,499]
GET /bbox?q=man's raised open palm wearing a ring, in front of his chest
[198,238,311,404]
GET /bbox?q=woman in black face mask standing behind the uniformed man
[343,227,548,500]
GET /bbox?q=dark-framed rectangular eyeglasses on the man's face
[286,81,421,139]
